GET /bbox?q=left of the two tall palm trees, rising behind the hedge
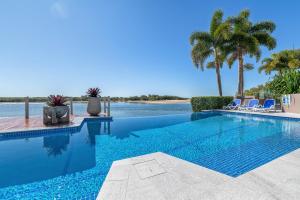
[190,10,230,96]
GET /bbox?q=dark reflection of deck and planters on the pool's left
[0,121,110,188]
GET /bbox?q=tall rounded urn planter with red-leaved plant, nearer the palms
[87,88,101,116]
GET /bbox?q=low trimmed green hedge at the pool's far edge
[191,96,233,112]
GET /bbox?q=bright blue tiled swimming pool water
[0,112,300,199]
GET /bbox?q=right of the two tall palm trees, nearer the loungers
[226,10,276,96]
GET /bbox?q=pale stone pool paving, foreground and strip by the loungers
[97,111,300,200]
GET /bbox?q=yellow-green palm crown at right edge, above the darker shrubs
[258,49,300,75]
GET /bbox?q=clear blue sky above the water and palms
[0,0,300,97]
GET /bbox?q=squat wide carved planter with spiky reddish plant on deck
[43,95,69,124]
